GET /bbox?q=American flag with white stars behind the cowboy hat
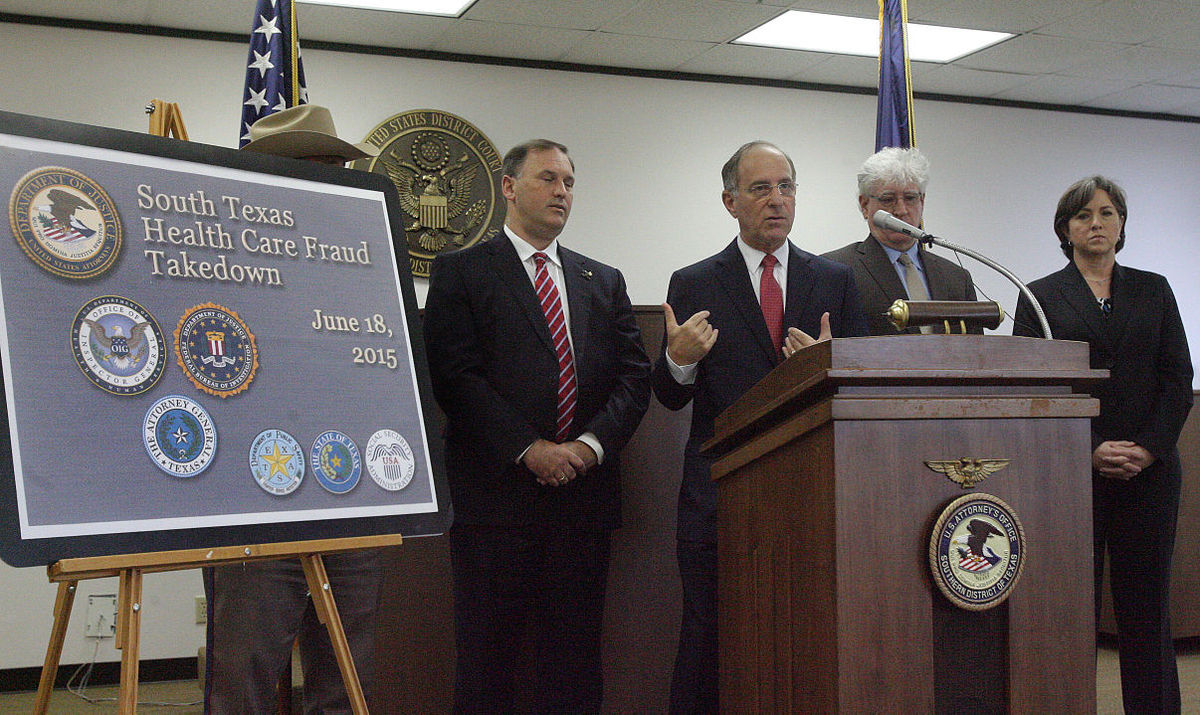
[238,0,308,148]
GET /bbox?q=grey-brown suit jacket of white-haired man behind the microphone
[824,236,983,335]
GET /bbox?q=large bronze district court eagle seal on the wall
[350,109,504,278]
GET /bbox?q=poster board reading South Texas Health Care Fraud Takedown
[0,113,450,566]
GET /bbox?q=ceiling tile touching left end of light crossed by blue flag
[602,0,782,42]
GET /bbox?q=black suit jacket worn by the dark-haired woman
[1013,263,1192,470]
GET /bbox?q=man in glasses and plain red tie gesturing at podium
[652,142,866,713]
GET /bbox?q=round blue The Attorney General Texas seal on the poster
[142,395,217,477]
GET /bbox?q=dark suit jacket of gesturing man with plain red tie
[653,239,866,543]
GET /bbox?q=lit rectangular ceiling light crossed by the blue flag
[733,10,1013,62]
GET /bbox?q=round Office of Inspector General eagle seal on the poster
[71,295,167,395]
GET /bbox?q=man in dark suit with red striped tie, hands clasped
[425,139,649,713]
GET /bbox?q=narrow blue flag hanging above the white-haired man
[875,0,917,151]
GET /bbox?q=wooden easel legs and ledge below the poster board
[34,534,402,715]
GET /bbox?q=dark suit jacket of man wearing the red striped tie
[425,235,649,529]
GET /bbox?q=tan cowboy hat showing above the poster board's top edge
[242,104,379,161]
